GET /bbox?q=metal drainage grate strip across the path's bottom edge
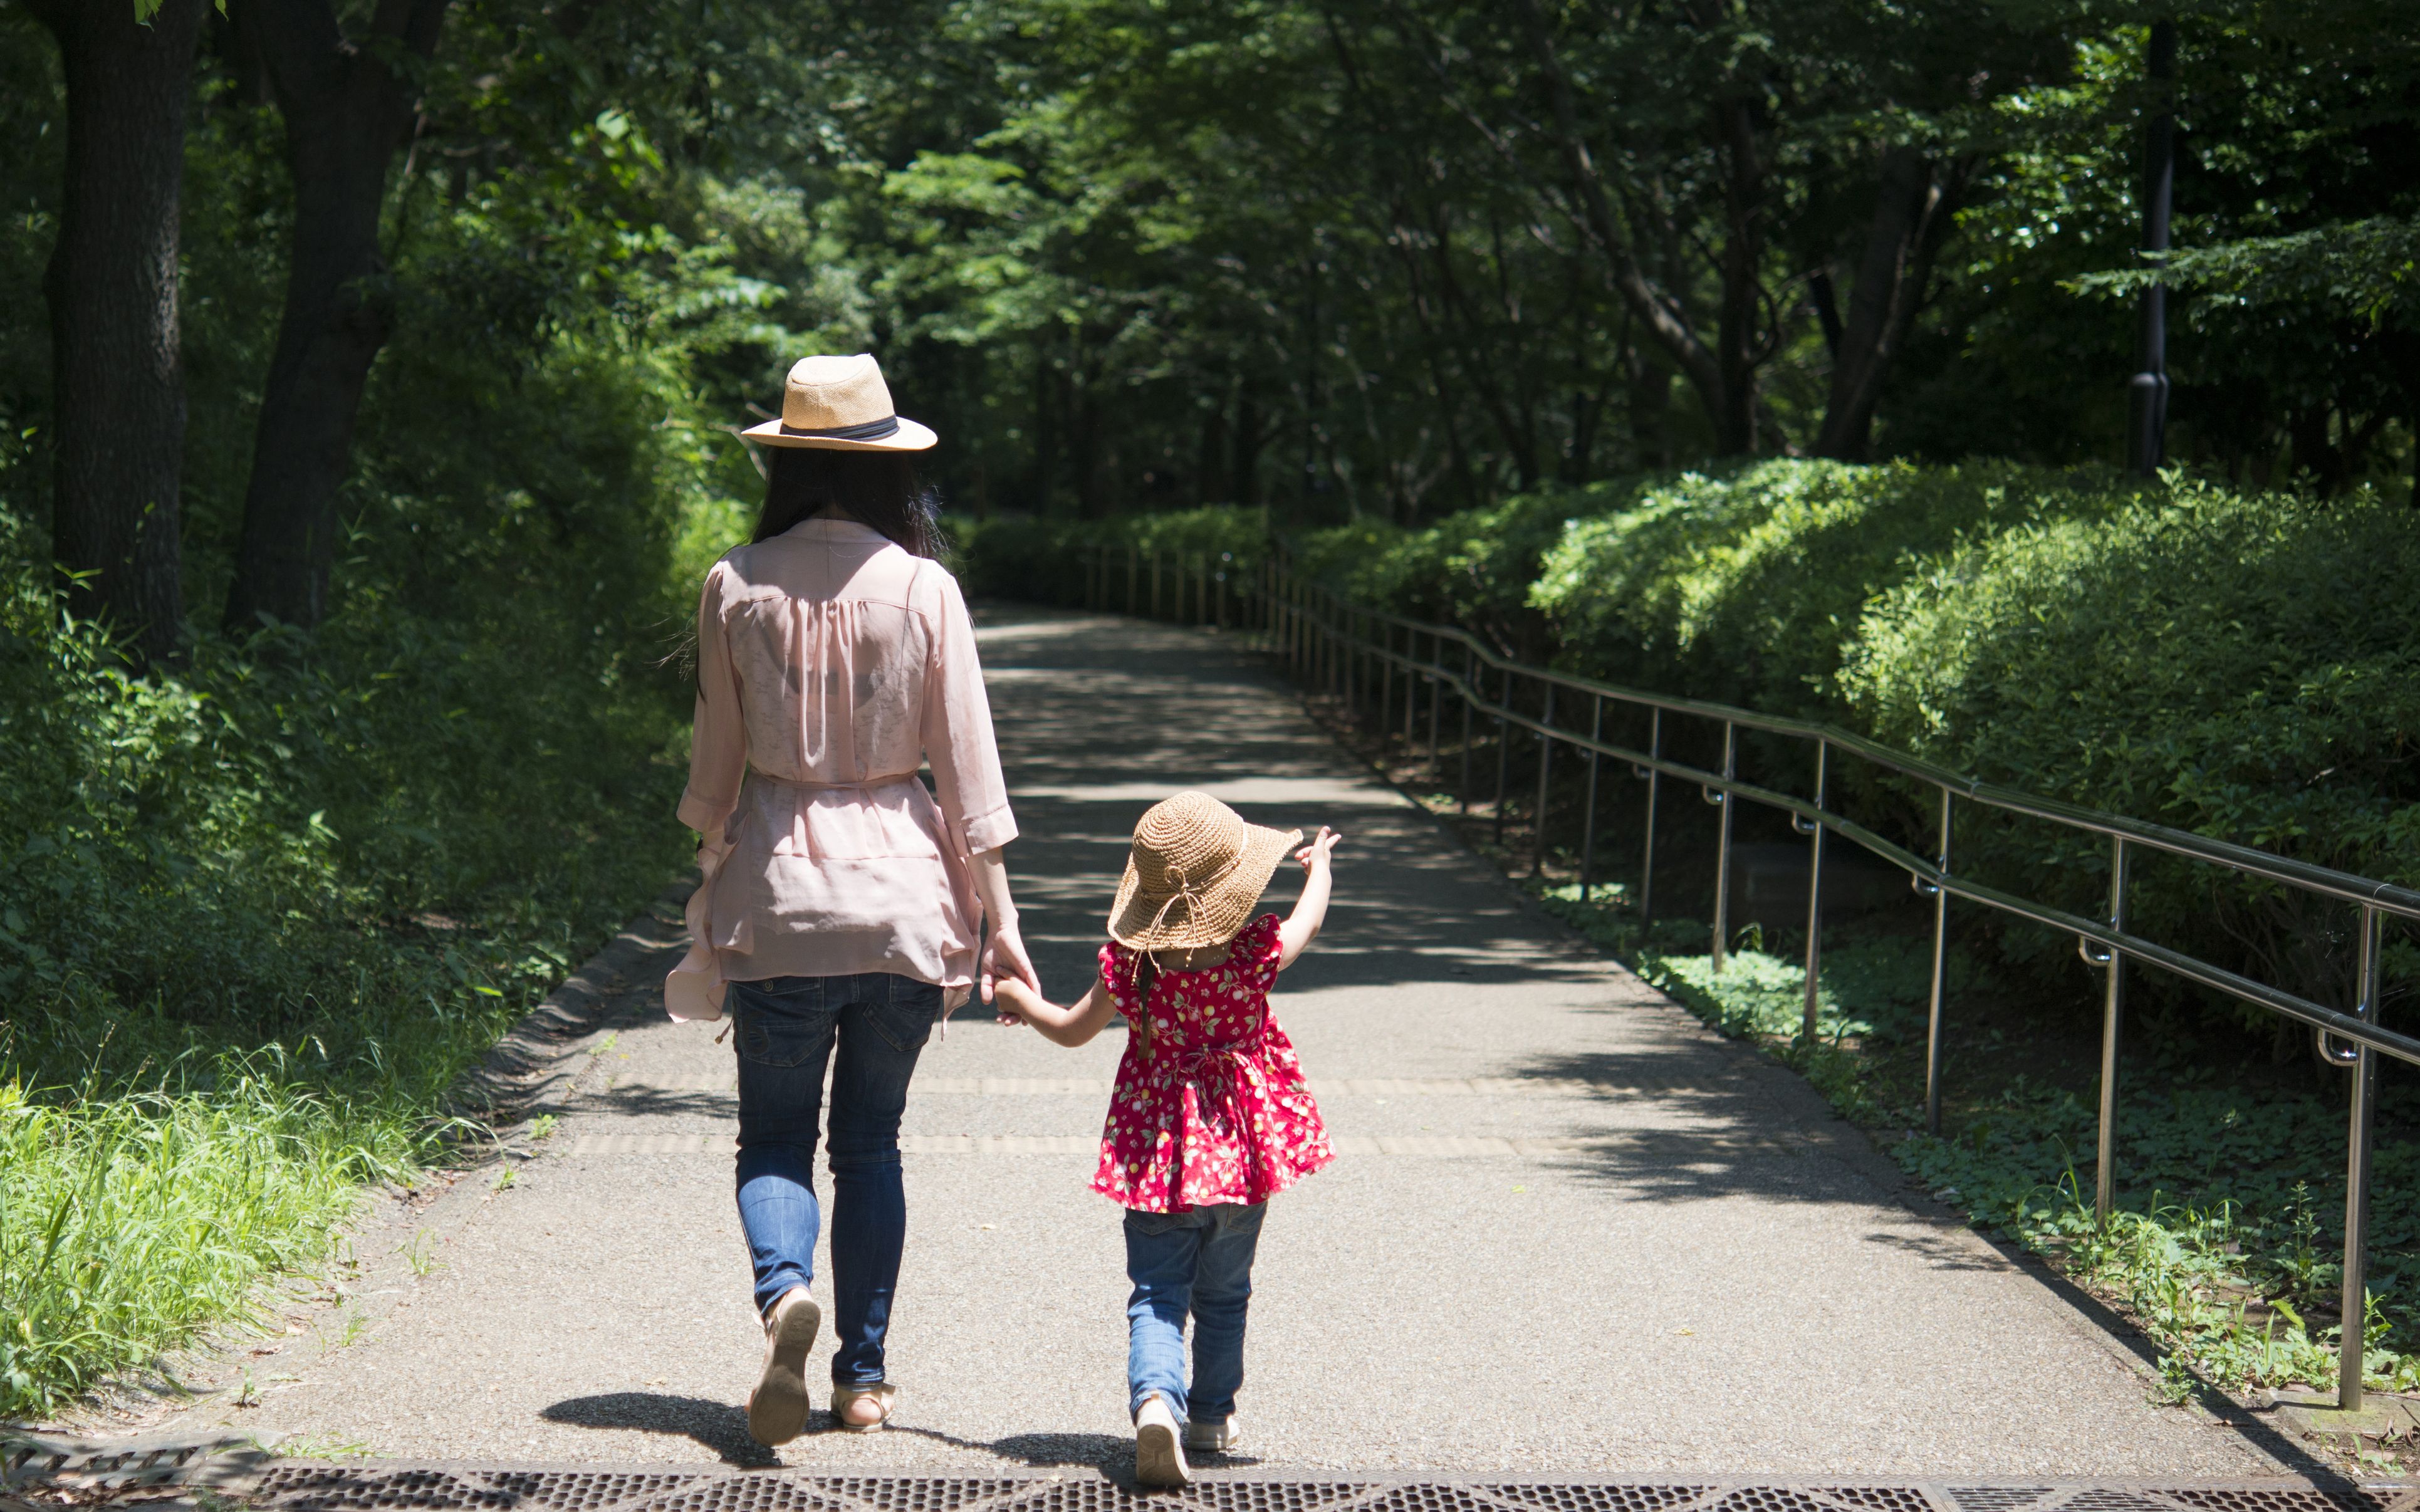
[212,1464,2420,1512]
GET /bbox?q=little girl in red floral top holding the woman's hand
[994,793,1341,1486]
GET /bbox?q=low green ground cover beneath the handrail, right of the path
[1541,885,2420,1400]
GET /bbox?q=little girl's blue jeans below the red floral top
[1125,1202,1268,1422]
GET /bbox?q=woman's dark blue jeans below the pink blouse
[728,972,941,1386]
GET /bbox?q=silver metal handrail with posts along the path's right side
[1082,547,2420,1408]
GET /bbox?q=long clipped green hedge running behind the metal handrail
[958,460,2420,1023]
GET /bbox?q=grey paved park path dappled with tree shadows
[194,610,2282,1478]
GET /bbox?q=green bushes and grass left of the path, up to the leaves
[0,47,754,1417]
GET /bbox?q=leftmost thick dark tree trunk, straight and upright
[29,0,203,663]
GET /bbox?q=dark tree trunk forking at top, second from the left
[227,0,446,629]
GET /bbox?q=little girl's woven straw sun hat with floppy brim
[1108,791,1302,951]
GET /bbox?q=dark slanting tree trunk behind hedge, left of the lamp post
[1815,148,1958,462]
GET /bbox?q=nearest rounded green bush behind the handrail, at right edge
[1839,481,2420,1001]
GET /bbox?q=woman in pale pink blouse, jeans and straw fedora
[665,356,1033,1444]
